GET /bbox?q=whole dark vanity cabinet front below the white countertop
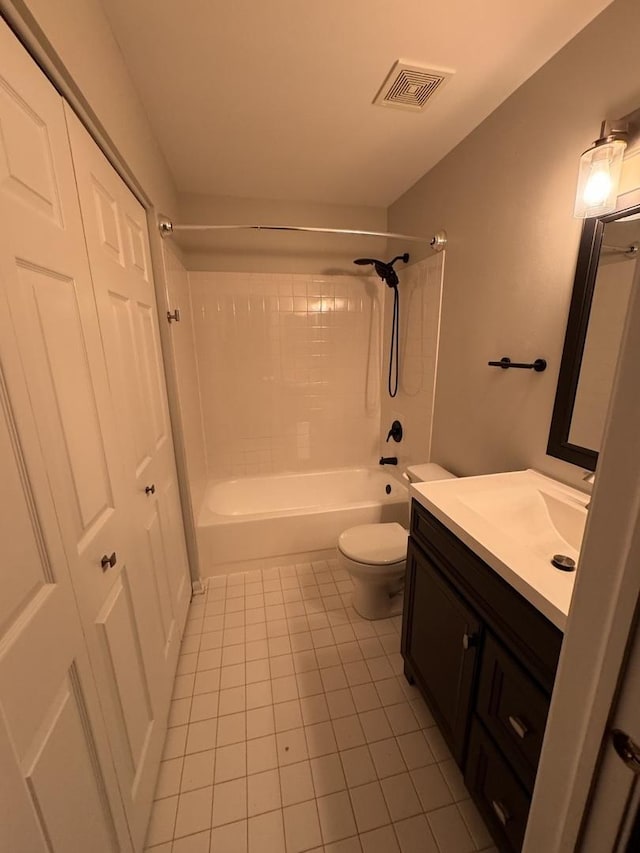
[402,500,563,853]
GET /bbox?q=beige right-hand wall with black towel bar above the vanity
[389,0,640,482]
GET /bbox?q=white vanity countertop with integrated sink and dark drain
[411,470,589,628]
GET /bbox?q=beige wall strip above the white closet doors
[7,0,177,214]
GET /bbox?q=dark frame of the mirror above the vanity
[547,190,640,471]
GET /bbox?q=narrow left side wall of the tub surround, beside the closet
[162,240,207,517]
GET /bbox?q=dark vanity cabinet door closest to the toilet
[402,539,481,764]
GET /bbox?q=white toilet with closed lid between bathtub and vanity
[338,462,455,619]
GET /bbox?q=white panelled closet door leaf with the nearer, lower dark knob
[0,16,178,850]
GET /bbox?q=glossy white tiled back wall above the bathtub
[189,272,384,479]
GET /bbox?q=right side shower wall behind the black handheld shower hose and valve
[380,252,445,475]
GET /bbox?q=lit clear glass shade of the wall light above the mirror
[573,136,627,219]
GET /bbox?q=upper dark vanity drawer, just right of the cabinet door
[476,633,549,791]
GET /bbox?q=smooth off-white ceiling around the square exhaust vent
[103,0,611,207]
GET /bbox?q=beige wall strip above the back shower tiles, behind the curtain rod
[173,194,387,275]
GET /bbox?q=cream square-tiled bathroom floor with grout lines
[147,560,497,853]
